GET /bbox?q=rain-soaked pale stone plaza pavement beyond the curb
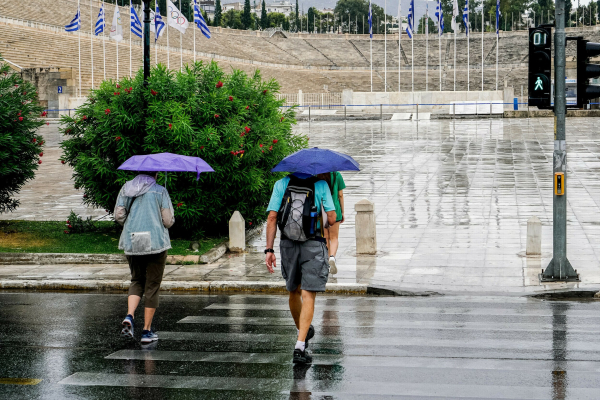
[0,118,600,293]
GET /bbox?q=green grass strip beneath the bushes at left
[0,221,226,255]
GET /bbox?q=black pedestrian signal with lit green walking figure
[528,27,552,109]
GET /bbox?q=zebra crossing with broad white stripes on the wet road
[60,295,600,399]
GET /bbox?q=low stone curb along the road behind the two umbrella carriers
[0,279,368,295]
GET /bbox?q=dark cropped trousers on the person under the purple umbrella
[127,250,167,308]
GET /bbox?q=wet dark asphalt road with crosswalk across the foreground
[0,292,600,400]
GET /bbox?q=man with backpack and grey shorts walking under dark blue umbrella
[265,148,358,364]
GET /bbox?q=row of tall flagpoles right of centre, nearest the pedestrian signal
[368,0,500,92]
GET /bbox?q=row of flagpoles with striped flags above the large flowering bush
[65,0,210,96]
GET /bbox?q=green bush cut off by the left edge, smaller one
[0,58,44,213]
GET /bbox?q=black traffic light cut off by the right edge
[577,37,600,108]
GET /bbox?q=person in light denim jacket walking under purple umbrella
[114,153,214,344]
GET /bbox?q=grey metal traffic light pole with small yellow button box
[540,0,579,282]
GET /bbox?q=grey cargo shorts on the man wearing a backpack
[279,240,329,292]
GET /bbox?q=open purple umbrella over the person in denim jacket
[118,153,215,180]
